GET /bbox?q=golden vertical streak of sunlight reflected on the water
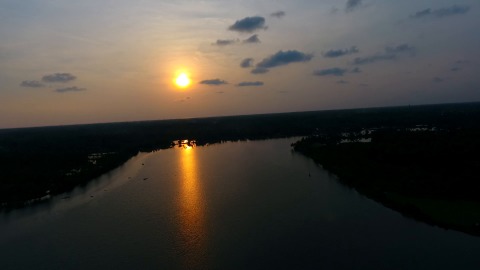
[179,146,206,269]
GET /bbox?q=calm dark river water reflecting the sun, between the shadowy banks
[0,139,480,269]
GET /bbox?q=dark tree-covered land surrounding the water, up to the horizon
[0,103,480,235]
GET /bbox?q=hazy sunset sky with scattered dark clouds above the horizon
[0,0,480,128]
